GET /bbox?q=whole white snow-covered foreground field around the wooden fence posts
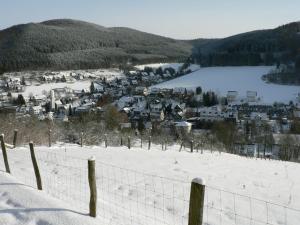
[0,144,300,225]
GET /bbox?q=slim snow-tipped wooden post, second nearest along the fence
[88,157,97,217]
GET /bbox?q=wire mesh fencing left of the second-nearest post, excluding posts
[0,148,89,212]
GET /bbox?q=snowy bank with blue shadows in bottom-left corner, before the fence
[0,171,95,225]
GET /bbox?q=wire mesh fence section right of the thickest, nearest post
[204,186,300,225]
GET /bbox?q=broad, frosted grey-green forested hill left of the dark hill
[0,19,192,71]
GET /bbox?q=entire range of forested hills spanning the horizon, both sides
[0,19,300,72]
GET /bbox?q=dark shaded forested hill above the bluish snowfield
[191,22,300,66]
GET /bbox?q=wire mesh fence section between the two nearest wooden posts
[96,162,190,225]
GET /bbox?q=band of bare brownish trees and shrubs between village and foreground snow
[0,109,300,161]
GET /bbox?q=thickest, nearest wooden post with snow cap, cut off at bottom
[188,178,205,225]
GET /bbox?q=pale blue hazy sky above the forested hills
[0,0,300,39]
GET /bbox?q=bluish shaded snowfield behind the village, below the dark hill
[155,66,300,103]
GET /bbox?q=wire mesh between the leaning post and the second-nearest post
[36,151,89,212]
